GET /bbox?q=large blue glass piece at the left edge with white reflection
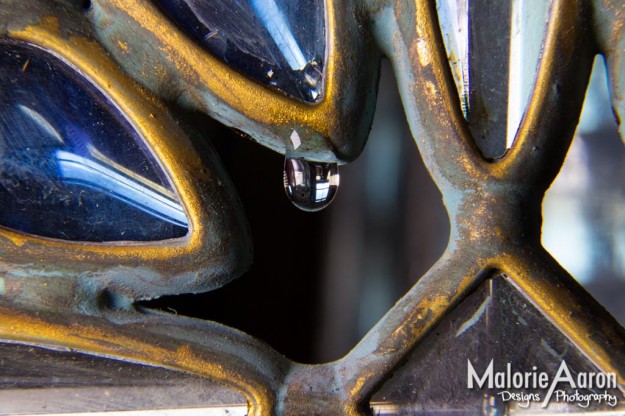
[0,43,189,242]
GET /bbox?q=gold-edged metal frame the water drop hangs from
[90,0,379,161]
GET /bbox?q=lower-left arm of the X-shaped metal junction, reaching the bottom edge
[280,252,488,415]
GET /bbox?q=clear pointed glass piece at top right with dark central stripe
[436,0,552,159]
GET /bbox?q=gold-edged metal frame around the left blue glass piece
[0,2,250,297]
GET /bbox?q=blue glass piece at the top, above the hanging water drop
[154,0,326,103]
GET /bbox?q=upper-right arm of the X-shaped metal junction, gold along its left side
[493,0,596,190]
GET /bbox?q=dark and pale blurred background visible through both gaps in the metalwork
[144,58,625,363]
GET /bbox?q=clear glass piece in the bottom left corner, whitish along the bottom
[0,343,247,416]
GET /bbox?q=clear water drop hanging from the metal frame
[284,157,339,211]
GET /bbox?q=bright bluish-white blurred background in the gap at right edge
[542,56,625,325]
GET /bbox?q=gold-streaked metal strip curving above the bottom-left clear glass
[0,302,289,415]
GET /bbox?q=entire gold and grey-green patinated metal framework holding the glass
[0,0,625,415]
